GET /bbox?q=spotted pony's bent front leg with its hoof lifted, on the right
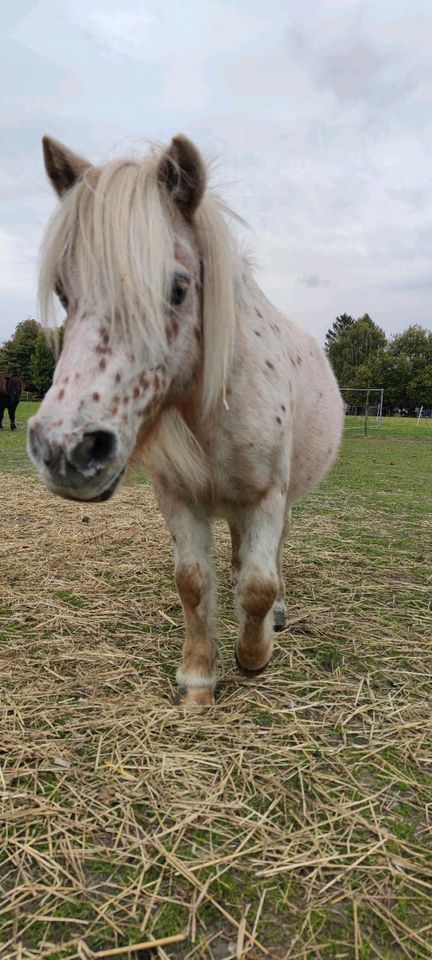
[236,487,286,674]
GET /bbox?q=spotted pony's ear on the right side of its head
[158,134,206,220]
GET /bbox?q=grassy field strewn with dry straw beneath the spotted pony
[0,404,432,960]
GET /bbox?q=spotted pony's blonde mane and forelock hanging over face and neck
[39,142,241,415]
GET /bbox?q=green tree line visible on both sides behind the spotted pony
[0,313,432,412]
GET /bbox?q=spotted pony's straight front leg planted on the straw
[156,487,218,707]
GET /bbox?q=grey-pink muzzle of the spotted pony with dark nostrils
[28,420,123,500]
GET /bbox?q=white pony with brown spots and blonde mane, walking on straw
[28,135,343,709]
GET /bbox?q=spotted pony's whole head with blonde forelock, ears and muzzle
[28,136,235,500]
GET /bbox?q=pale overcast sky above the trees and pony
[0,0,432,342]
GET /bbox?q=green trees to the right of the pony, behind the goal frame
[325,313,432,413]
